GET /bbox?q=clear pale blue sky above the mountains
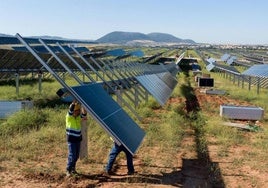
[0,0,268,44]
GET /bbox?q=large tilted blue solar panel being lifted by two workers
[72,83,145,154]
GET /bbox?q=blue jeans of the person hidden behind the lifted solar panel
[106,143,134,173]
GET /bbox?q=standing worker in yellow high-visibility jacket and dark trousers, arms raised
[66,101,87,176]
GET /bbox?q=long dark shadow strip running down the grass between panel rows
[181,72,225,187]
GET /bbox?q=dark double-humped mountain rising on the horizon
[95,31,195,44]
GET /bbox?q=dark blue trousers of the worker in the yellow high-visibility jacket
[66,142,80,171]
